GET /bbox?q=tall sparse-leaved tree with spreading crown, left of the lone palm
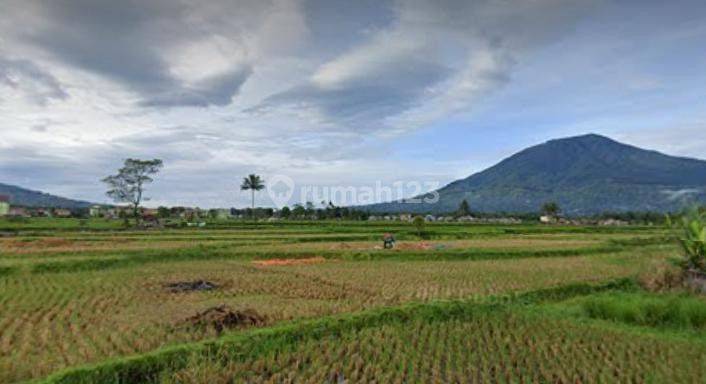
[102,159,163,223]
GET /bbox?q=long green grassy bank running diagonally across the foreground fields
[41,279,634,384]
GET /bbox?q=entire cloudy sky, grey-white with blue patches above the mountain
[0,0,706,207]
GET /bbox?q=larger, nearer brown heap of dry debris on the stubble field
[184,304,266,334]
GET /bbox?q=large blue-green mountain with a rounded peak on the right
[366,134,706,215]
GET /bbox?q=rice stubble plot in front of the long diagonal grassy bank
[161,302,706,383]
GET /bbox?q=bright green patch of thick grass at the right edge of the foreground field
[582,293,706,329]
